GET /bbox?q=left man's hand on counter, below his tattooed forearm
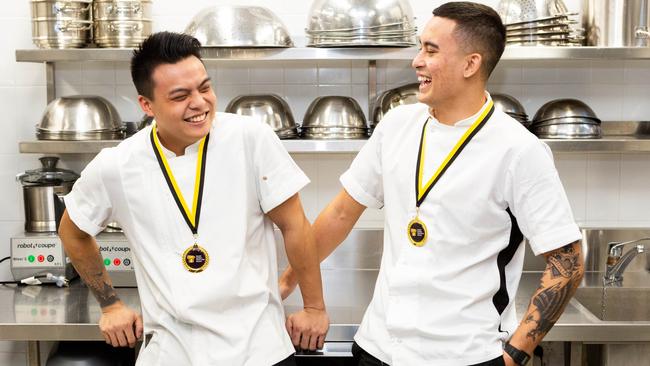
[99,301,142,348]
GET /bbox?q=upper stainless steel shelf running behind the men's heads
[16,47,650,62]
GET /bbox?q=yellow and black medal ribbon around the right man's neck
[415,100,494,208]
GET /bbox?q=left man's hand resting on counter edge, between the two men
[286,308,330,351]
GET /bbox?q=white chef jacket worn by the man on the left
[65,113,309,366]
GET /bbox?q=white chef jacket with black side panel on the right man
[341,93,581,366]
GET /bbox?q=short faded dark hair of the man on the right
[433,1,506,79]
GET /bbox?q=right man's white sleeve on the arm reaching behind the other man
[340,122,382,208]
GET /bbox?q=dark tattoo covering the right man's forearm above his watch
[524,243,582,341]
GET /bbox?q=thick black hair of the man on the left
[131,32,201,100]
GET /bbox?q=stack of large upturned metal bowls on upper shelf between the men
[305,0,417,47]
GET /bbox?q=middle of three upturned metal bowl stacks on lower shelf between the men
[301,95,368,140]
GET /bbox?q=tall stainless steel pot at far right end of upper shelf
[587,0,650,47]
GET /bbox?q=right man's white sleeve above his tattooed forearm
[506,140,582,255]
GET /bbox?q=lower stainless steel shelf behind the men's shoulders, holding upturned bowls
[19,136,650,154]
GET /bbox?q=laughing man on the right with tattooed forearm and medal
[281,2,584,366]
